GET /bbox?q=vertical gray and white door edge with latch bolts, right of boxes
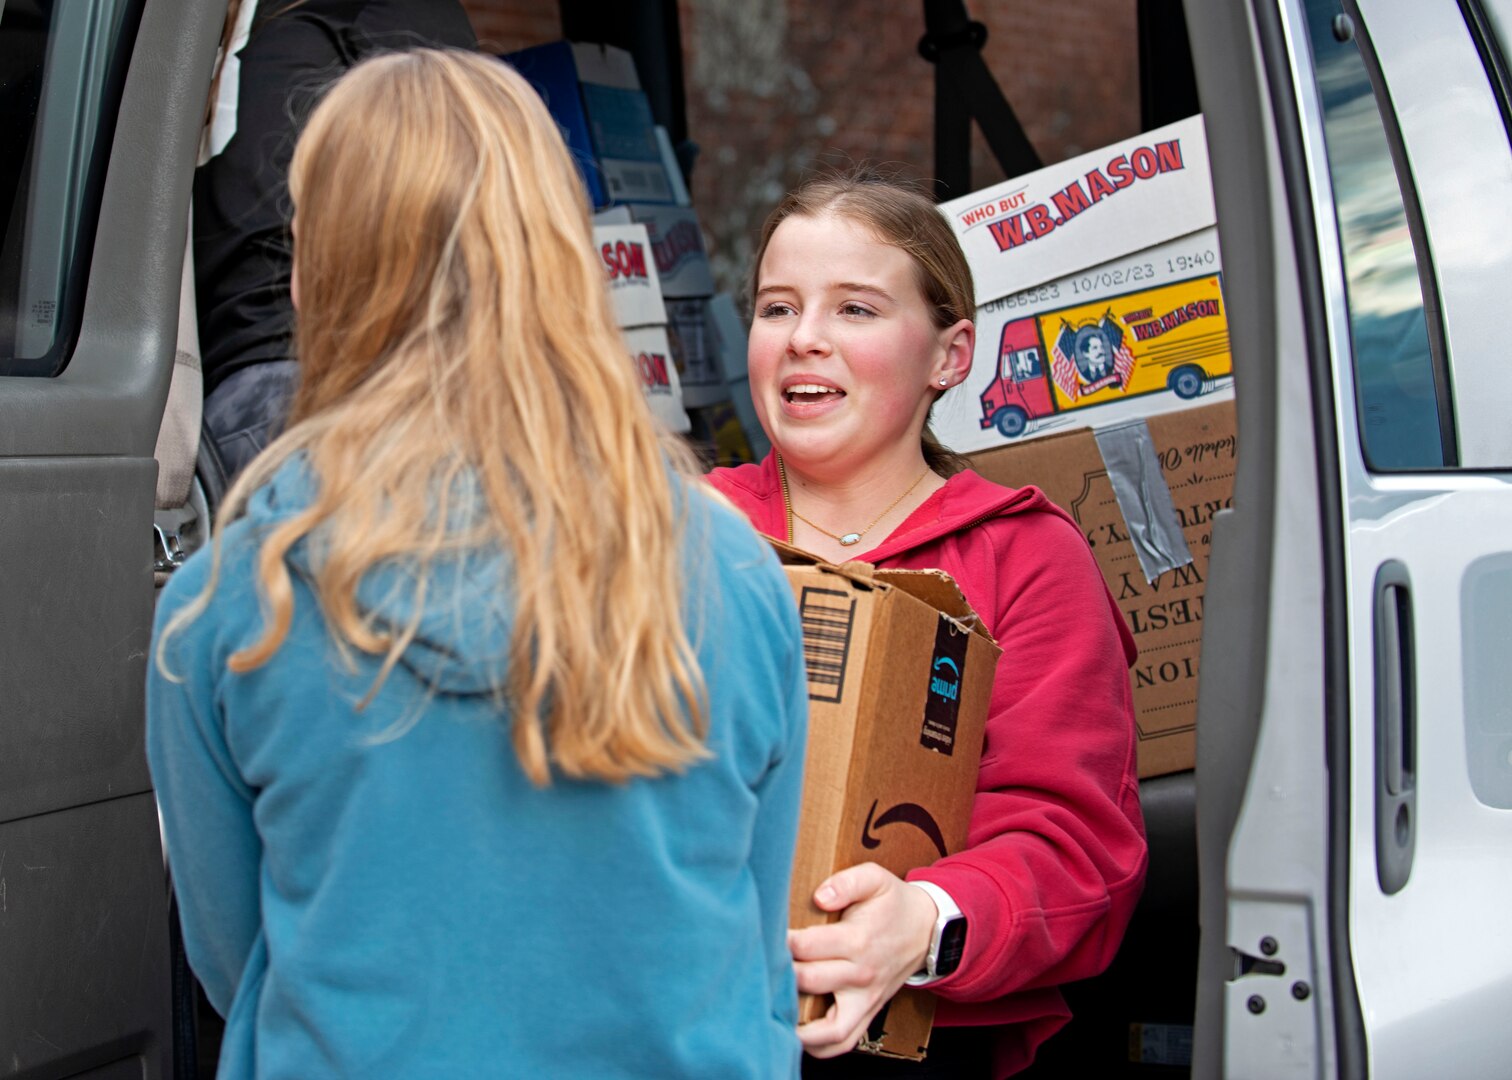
[1187,0,1368,1080]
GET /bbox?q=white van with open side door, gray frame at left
[0,0,1512,1080]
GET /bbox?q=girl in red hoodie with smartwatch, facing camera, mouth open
[711,175,1146,1078]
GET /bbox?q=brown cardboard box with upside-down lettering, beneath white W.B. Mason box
[972,401,1237,776]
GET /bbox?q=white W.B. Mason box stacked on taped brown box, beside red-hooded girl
[934,116,1235,776]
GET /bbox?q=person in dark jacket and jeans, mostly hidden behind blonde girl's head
[194,0,478,476]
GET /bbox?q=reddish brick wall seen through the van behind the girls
[464,0,1139,290]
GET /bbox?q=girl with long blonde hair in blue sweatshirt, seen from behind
[148,51,806,1080]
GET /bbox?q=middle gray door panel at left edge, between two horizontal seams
[0,458,156,821]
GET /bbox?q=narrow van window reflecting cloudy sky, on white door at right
[1306,0,1453,470]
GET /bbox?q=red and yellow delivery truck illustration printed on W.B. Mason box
[981,275,1234,439]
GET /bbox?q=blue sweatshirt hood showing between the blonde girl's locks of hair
[245,458,514,694]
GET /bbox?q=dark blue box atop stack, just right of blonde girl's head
[502,41,676,206]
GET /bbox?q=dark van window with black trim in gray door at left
[0,0,139,375]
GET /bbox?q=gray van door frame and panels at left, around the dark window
[0,0,225,1077]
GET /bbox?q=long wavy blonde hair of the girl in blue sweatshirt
[159,50,708,784]
